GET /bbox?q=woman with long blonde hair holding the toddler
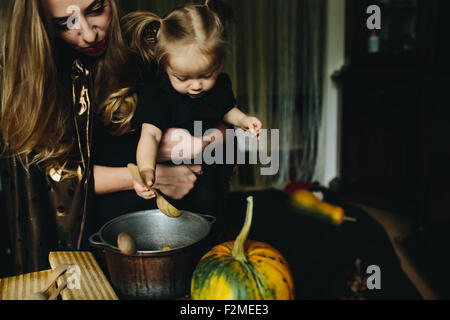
[0,0,230,274]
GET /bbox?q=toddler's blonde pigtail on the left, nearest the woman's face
[122,11,162,63]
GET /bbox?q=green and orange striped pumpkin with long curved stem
[191,197,294,300]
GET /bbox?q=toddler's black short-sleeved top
[132,73,236,135]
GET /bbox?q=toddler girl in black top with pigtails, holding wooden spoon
[124,1,262,199]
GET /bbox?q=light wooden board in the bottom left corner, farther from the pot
[0,270,55,300]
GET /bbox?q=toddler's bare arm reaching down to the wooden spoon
[136,123,162,187]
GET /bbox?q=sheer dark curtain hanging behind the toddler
[119,0,327,189]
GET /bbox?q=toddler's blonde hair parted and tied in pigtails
[122,2,226,69]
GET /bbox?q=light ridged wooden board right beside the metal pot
[49,252,119,300]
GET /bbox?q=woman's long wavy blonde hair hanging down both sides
[0,0,136,174]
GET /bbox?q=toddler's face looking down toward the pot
[166,50,220,99]
